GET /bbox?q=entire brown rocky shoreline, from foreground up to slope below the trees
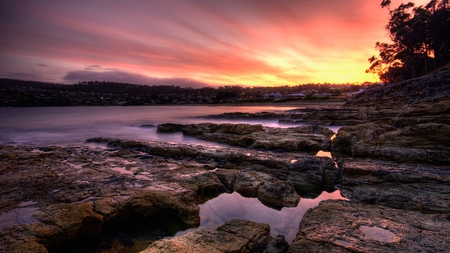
[0,70,450,253]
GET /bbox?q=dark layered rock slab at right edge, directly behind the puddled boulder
[341,158,450,213]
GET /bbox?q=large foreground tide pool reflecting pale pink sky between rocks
[177,191,345,243]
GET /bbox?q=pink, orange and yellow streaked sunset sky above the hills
[0,0,428,88]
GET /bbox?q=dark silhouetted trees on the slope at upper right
[366,0,450,82]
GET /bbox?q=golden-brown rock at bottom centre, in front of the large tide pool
[142,220,271,253]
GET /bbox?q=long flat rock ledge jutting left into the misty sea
[157,123,334,151]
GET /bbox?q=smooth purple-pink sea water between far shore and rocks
[0,106,299,145]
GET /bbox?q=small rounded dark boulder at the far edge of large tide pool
[258,182,300,208]
